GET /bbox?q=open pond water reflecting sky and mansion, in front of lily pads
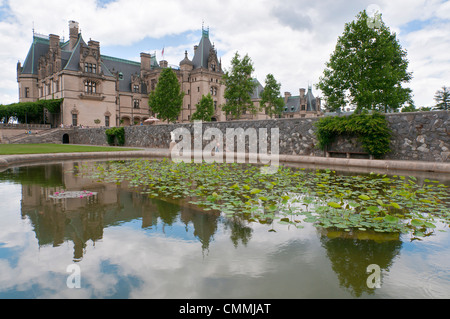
[0,161,450,299]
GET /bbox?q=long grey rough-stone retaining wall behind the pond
[30,111,450,163]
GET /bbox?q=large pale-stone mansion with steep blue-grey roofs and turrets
[17,21,321,127]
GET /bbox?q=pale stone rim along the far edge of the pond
[0,149,450,174]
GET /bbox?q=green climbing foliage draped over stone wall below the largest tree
[316,113,391,158]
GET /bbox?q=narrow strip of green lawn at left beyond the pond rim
[0,144,137,155]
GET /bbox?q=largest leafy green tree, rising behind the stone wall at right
[317,11,412,112]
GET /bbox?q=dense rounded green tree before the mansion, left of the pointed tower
[148,68,184,123]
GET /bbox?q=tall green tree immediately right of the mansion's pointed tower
[222,52,258,119]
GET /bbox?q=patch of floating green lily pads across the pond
[80,159,450,236]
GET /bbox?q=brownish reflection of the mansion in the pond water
[18,163,230,260]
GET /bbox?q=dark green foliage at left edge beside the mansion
[0,99,63,124]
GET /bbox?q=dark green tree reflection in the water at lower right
[320,234,402,297]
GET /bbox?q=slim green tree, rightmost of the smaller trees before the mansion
[259,74,284,118]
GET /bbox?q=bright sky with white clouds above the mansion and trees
[0,0,450,106]
